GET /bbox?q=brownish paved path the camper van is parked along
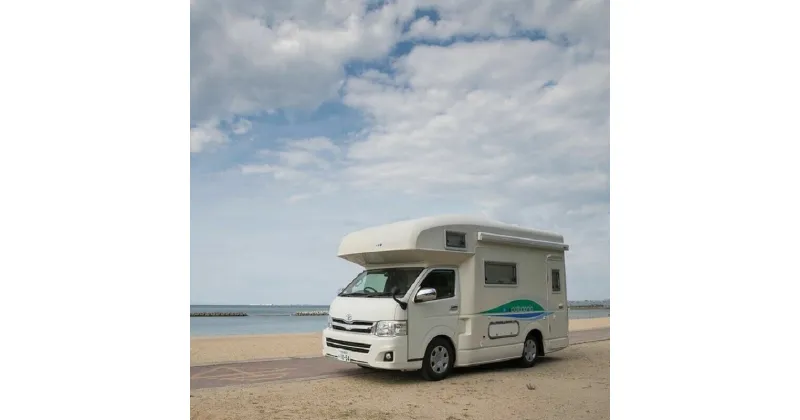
[190,328,611,389]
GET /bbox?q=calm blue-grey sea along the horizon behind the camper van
[190,305,610,337]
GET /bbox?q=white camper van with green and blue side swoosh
[322,216,569,381]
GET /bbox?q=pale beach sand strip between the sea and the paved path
[191,318,610,366]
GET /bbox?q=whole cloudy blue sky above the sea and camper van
[191,0,610,304]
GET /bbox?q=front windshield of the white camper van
[339,267,422,297]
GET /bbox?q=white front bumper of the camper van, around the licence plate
[322,328,422,370]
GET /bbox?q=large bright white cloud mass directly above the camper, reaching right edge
[244,40,609,286]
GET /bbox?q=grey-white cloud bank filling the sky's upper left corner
[191,0,413,150]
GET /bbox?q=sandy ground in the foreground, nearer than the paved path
[190,341,610,420]
